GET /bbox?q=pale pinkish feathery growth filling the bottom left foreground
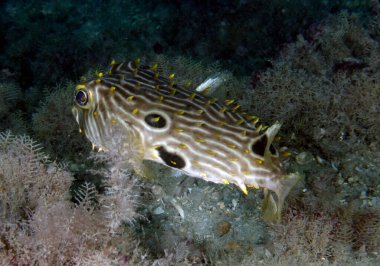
[0,132,147,265]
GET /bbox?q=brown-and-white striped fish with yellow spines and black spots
[72,59,300,222]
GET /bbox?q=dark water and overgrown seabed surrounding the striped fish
[0,0,380,265]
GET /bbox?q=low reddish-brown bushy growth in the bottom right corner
[241,205,380,265]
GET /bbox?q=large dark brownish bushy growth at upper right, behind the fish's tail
[252,13,380,156]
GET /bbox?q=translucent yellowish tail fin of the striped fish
[261,173,301,223]
